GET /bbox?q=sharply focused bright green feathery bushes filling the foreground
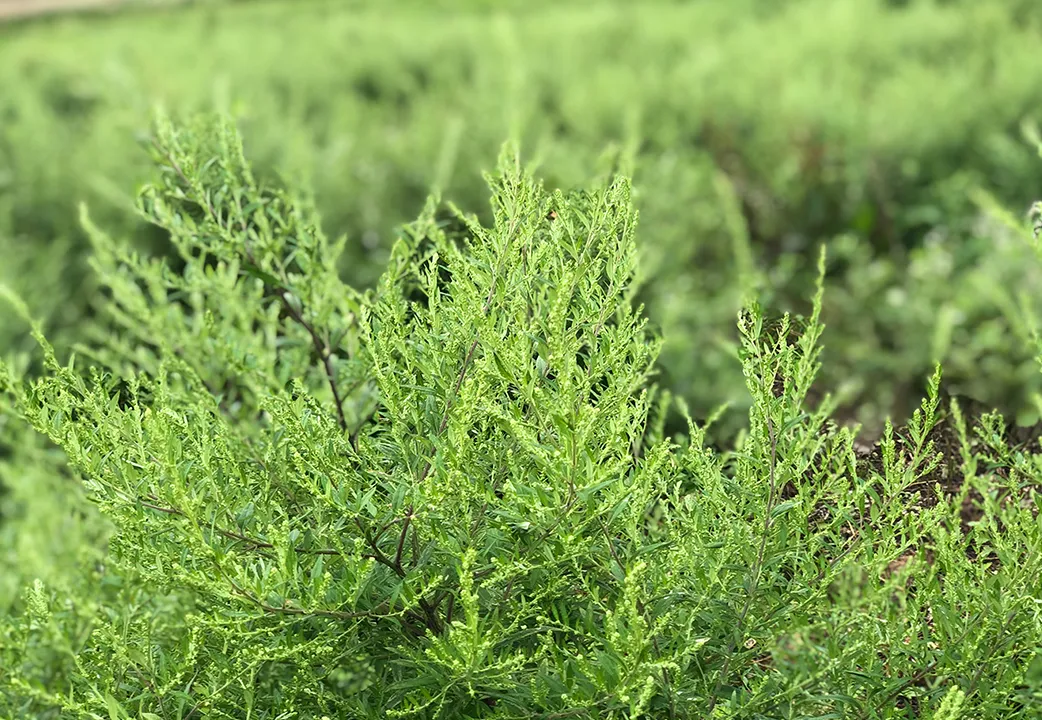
[0,115,1042,720]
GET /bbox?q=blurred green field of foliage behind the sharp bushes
[0,0,1042,550]
